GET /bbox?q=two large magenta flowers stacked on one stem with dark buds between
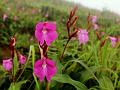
[34,22,57,82]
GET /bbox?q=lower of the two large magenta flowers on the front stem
[34,57,57,81]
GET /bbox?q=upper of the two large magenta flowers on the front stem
[35,22,57,45]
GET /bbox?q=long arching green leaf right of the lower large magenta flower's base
[52,74,87,90]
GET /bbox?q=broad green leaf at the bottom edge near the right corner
[99,76,114,90]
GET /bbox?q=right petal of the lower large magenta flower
[46,59,57,81]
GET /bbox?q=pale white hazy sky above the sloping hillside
[66,0,120,15]
